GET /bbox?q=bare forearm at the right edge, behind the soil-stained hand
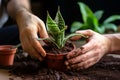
[105,34,120,52]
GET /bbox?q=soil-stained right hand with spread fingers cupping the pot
[65,30,111,70]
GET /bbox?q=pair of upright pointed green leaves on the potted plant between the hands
[46,10,66,48]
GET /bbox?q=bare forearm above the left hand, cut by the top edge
[7,0,31,18]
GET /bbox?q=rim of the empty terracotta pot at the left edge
[0,45,17,54]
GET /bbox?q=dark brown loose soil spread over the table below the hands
[5,49,120,80]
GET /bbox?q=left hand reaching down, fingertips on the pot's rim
[16,11,48,61]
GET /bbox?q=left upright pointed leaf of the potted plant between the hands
[46,13,61,47]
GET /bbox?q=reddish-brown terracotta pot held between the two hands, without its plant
[45,44,76,71]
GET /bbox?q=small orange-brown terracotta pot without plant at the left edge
[0,45,17,66]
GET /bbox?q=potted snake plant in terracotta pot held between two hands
[45,8,85,71]
